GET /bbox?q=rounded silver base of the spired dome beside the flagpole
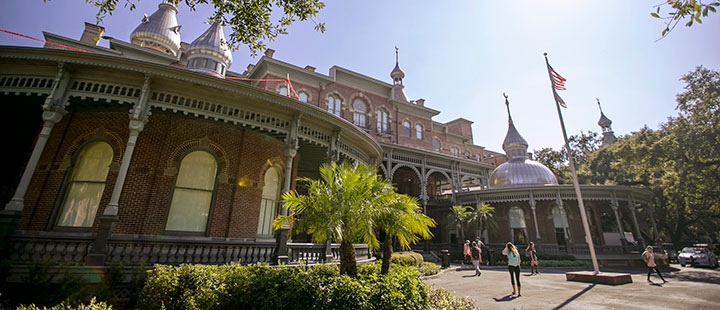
[490,157,558,188]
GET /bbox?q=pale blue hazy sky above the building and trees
[0,0,720,152]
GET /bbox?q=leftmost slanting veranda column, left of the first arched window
[5,111,64,211]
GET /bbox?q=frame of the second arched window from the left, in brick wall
[162,147,222,236]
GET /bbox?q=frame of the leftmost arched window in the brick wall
[47,138,118,232]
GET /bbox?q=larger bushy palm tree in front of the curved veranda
[273,162,392,277]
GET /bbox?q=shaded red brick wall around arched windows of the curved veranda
[22,111,292,238]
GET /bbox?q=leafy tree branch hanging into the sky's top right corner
[650,0,720,39]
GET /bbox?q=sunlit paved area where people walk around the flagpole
[425,265,720,310]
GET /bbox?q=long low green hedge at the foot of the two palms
[138,264,428,309]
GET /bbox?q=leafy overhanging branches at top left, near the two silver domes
[67,0,325,56]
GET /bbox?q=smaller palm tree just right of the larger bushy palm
[374,192,435,274]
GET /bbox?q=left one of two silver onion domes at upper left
[130,3,181,56]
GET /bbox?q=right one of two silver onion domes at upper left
[186,22,232,77]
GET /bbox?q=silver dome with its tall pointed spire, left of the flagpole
[490,96,558,188]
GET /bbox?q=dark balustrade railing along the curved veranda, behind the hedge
[8,232,370,266]
